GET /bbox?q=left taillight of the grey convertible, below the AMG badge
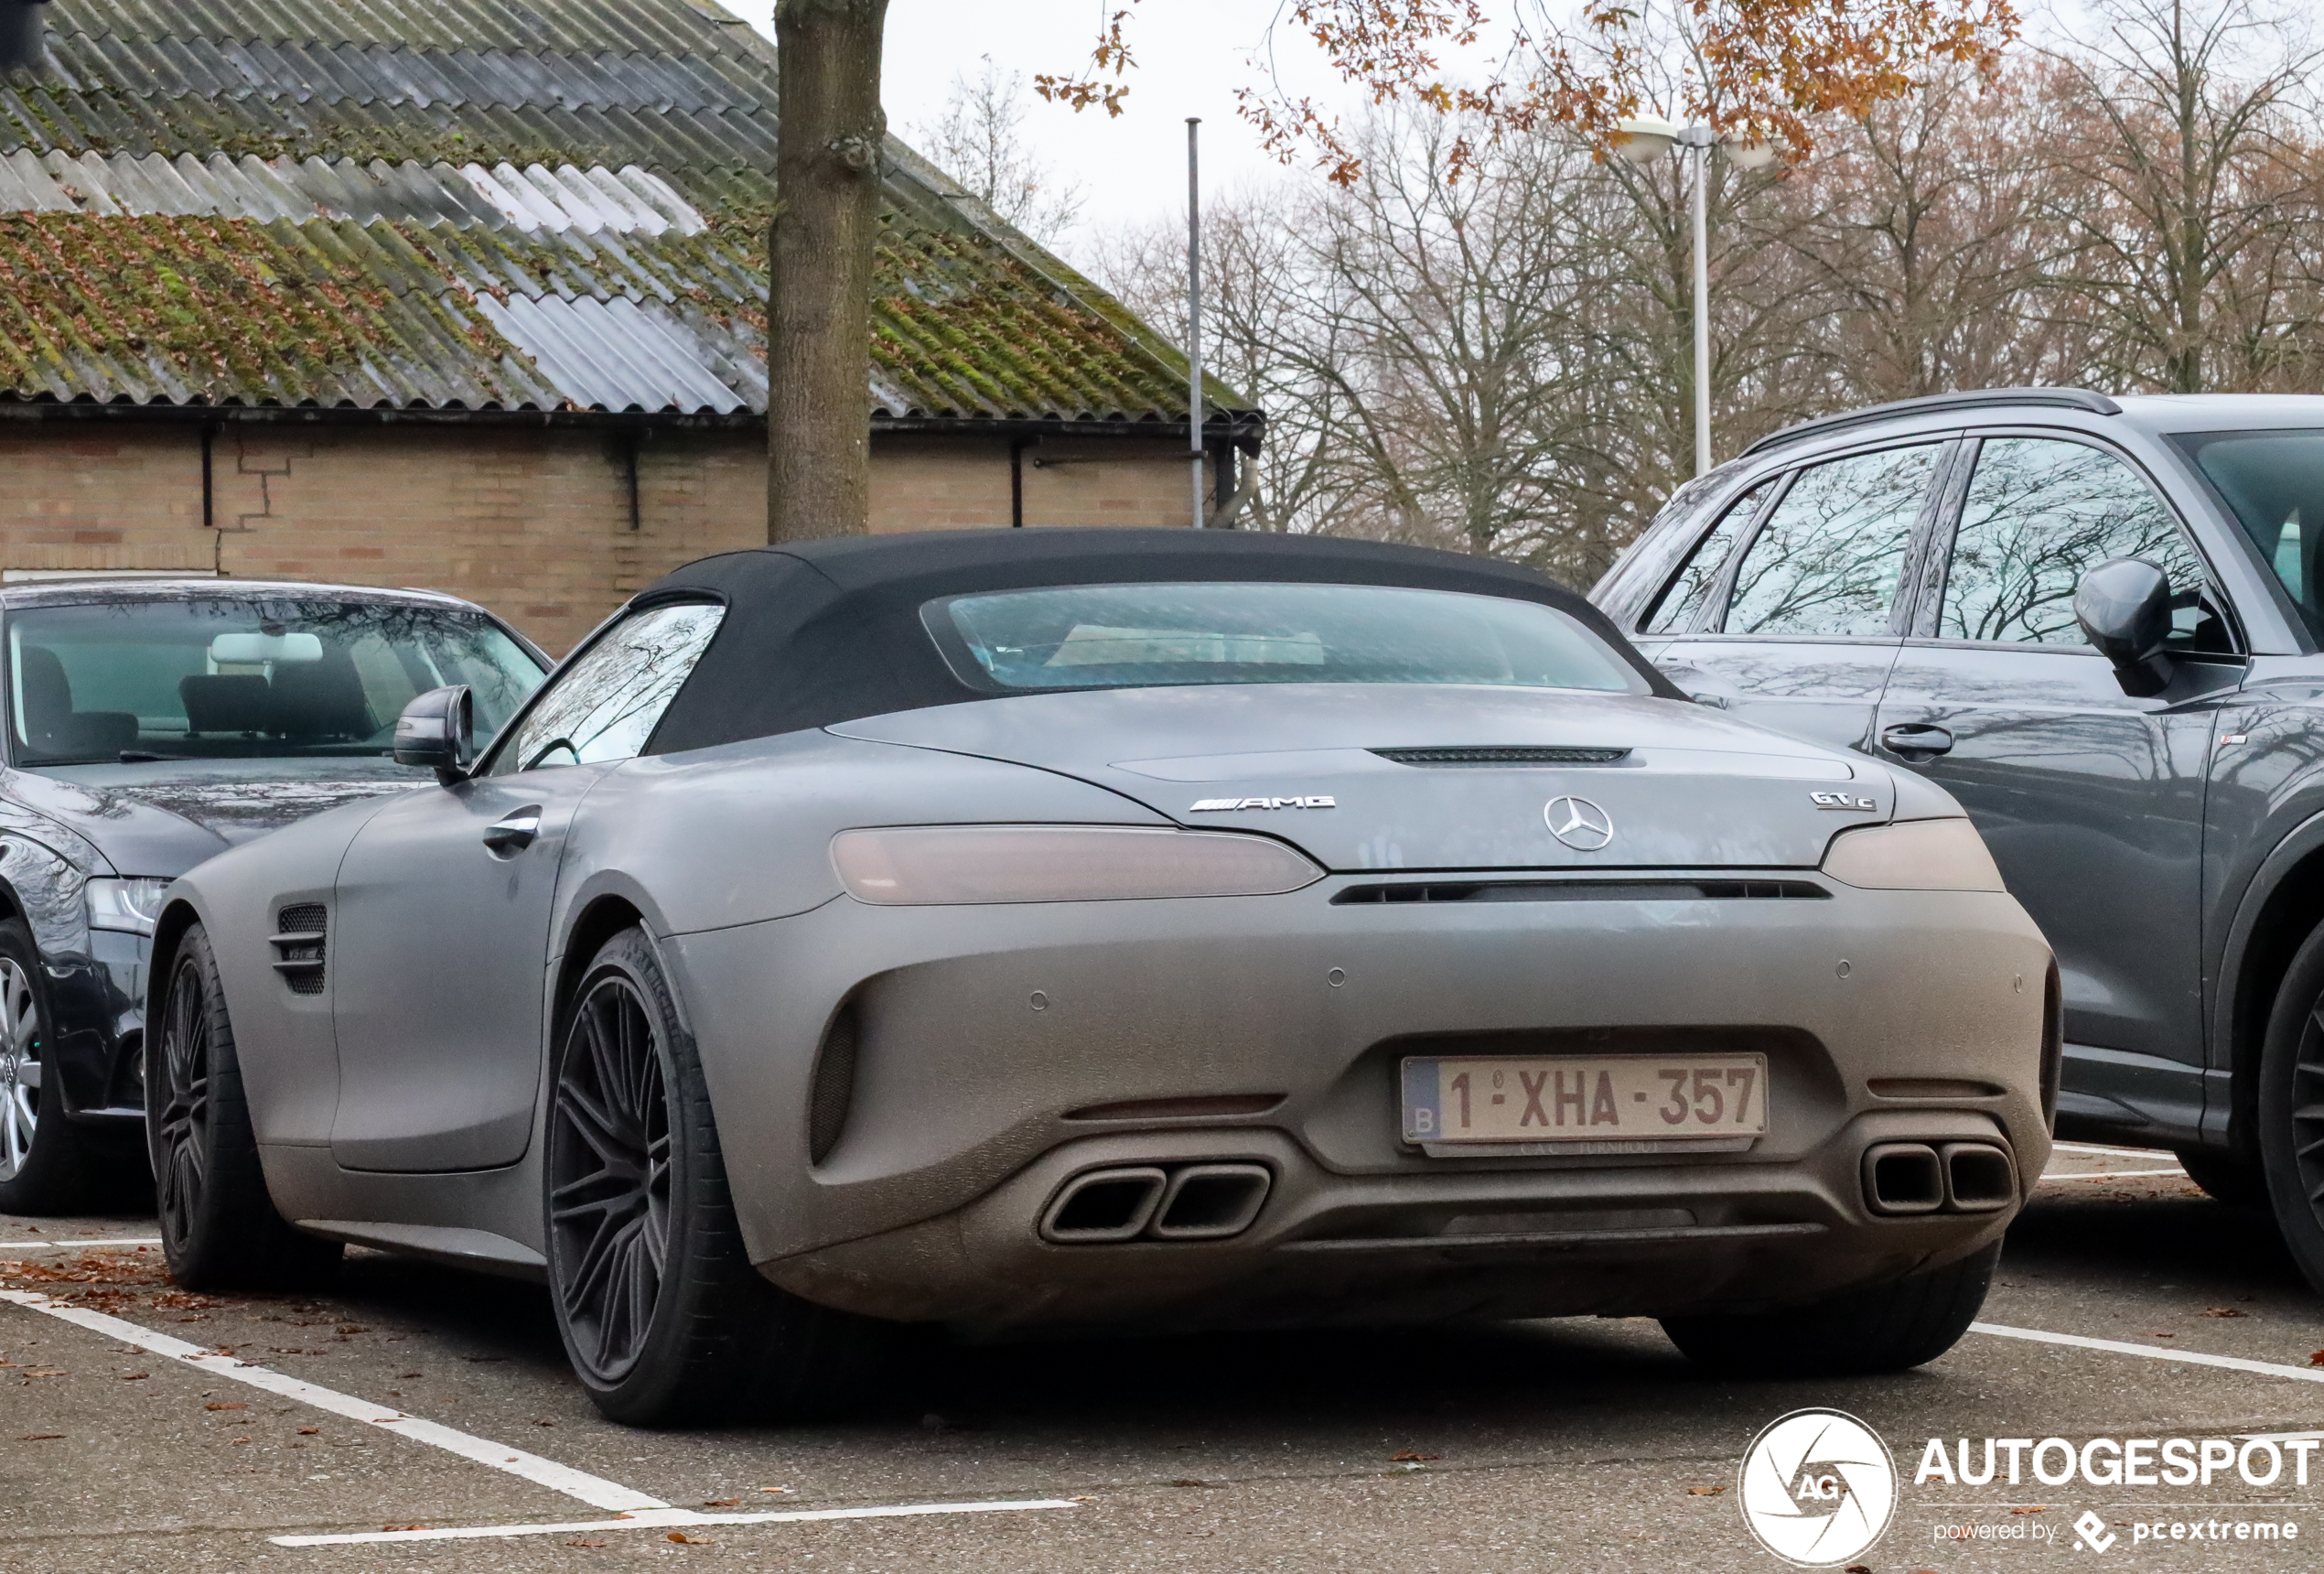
[832,825,1322,907]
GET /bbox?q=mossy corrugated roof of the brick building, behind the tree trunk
[0,0,1245,430]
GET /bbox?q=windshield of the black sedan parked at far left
[7,595,542,765]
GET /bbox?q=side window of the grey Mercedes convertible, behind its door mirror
[488,602,725,777]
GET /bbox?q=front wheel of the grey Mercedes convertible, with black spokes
[146,925,344,1290]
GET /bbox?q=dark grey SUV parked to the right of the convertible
[1592,388,2324,1288]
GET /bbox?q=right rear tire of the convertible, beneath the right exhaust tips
[1662,1242,2001,1376]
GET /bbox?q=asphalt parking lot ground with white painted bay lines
[0,1147,2324,1574]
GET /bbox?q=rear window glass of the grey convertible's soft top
[925,584,1648,693]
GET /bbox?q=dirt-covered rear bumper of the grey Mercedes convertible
[667,872,2050,1328]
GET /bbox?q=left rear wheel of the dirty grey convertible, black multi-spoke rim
[543,930,881,1425]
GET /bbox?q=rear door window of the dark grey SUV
[1727,442,1945,637]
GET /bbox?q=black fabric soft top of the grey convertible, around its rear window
[634,528,1685,753]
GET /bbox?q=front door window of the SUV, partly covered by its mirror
[1936,437,2224,649]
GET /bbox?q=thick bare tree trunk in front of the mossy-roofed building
[767,0,888,544]
